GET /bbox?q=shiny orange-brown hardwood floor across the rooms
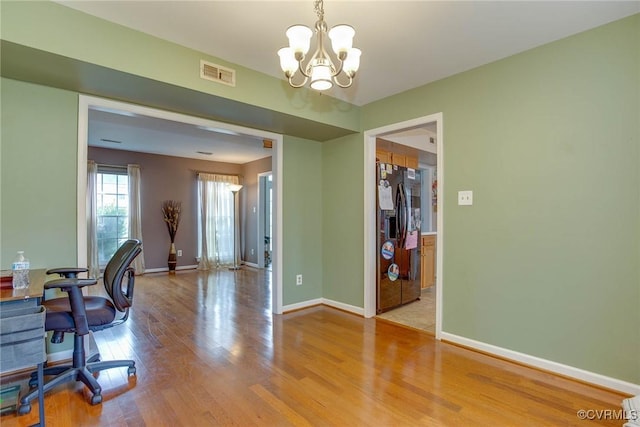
[1,267,625,427]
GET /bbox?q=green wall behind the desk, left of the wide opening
[0,79,78,269]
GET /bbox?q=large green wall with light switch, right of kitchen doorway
[360,15,640,383]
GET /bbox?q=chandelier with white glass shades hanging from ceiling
[278,0,362,90]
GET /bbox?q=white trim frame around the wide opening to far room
[76,95,284,314]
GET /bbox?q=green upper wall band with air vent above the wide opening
[0,0,359,135]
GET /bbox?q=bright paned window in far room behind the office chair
[96,171,129,268]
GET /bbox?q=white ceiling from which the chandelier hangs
[58,0,640,162]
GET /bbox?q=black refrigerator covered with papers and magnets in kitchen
[376,163,421,313]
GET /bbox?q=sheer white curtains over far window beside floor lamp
[198,173,239,270]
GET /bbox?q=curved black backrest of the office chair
[102,239,142,312]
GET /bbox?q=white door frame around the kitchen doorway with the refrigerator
[363,113,444,339]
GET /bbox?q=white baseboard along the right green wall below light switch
[440,331,640,395]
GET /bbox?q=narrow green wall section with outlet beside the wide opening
[282,137,323,305]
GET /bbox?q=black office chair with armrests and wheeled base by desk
[18,239,142,414]
